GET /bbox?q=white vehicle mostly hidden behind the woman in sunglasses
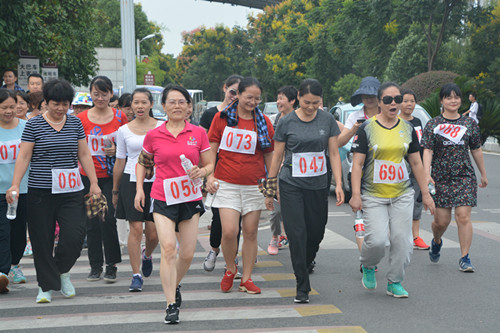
[330,103,431,202]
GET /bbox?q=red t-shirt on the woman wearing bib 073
[208,112,274,185]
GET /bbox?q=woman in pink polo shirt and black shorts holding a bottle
[135,85,214,324]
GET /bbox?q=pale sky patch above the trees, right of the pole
[134,0,261,57]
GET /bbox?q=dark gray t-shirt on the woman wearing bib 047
[274,111,340,190]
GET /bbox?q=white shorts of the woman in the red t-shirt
[212,180,266,216]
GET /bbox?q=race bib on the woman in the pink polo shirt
[163,175,202,205]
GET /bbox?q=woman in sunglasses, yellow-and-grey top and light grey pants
[349,82,434,297]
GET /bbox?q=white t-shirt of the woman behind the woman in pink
[116,120,163,175]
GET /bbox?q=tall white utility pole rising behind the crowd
[120,0,137,93]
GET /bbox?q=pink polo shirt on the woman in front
[142,122,210,201]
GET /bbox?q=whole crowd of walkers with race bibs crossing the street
[0,70,488,324]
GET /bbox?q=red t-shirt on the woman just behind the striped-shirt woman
[77,109,128,178]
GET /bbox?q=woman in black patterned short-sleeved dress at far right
[422,83,488,272]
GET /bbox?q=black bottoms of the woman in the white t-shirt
[116,173,153,222]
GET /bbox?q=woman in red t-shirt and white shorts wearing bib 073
[207,77,274,294]
